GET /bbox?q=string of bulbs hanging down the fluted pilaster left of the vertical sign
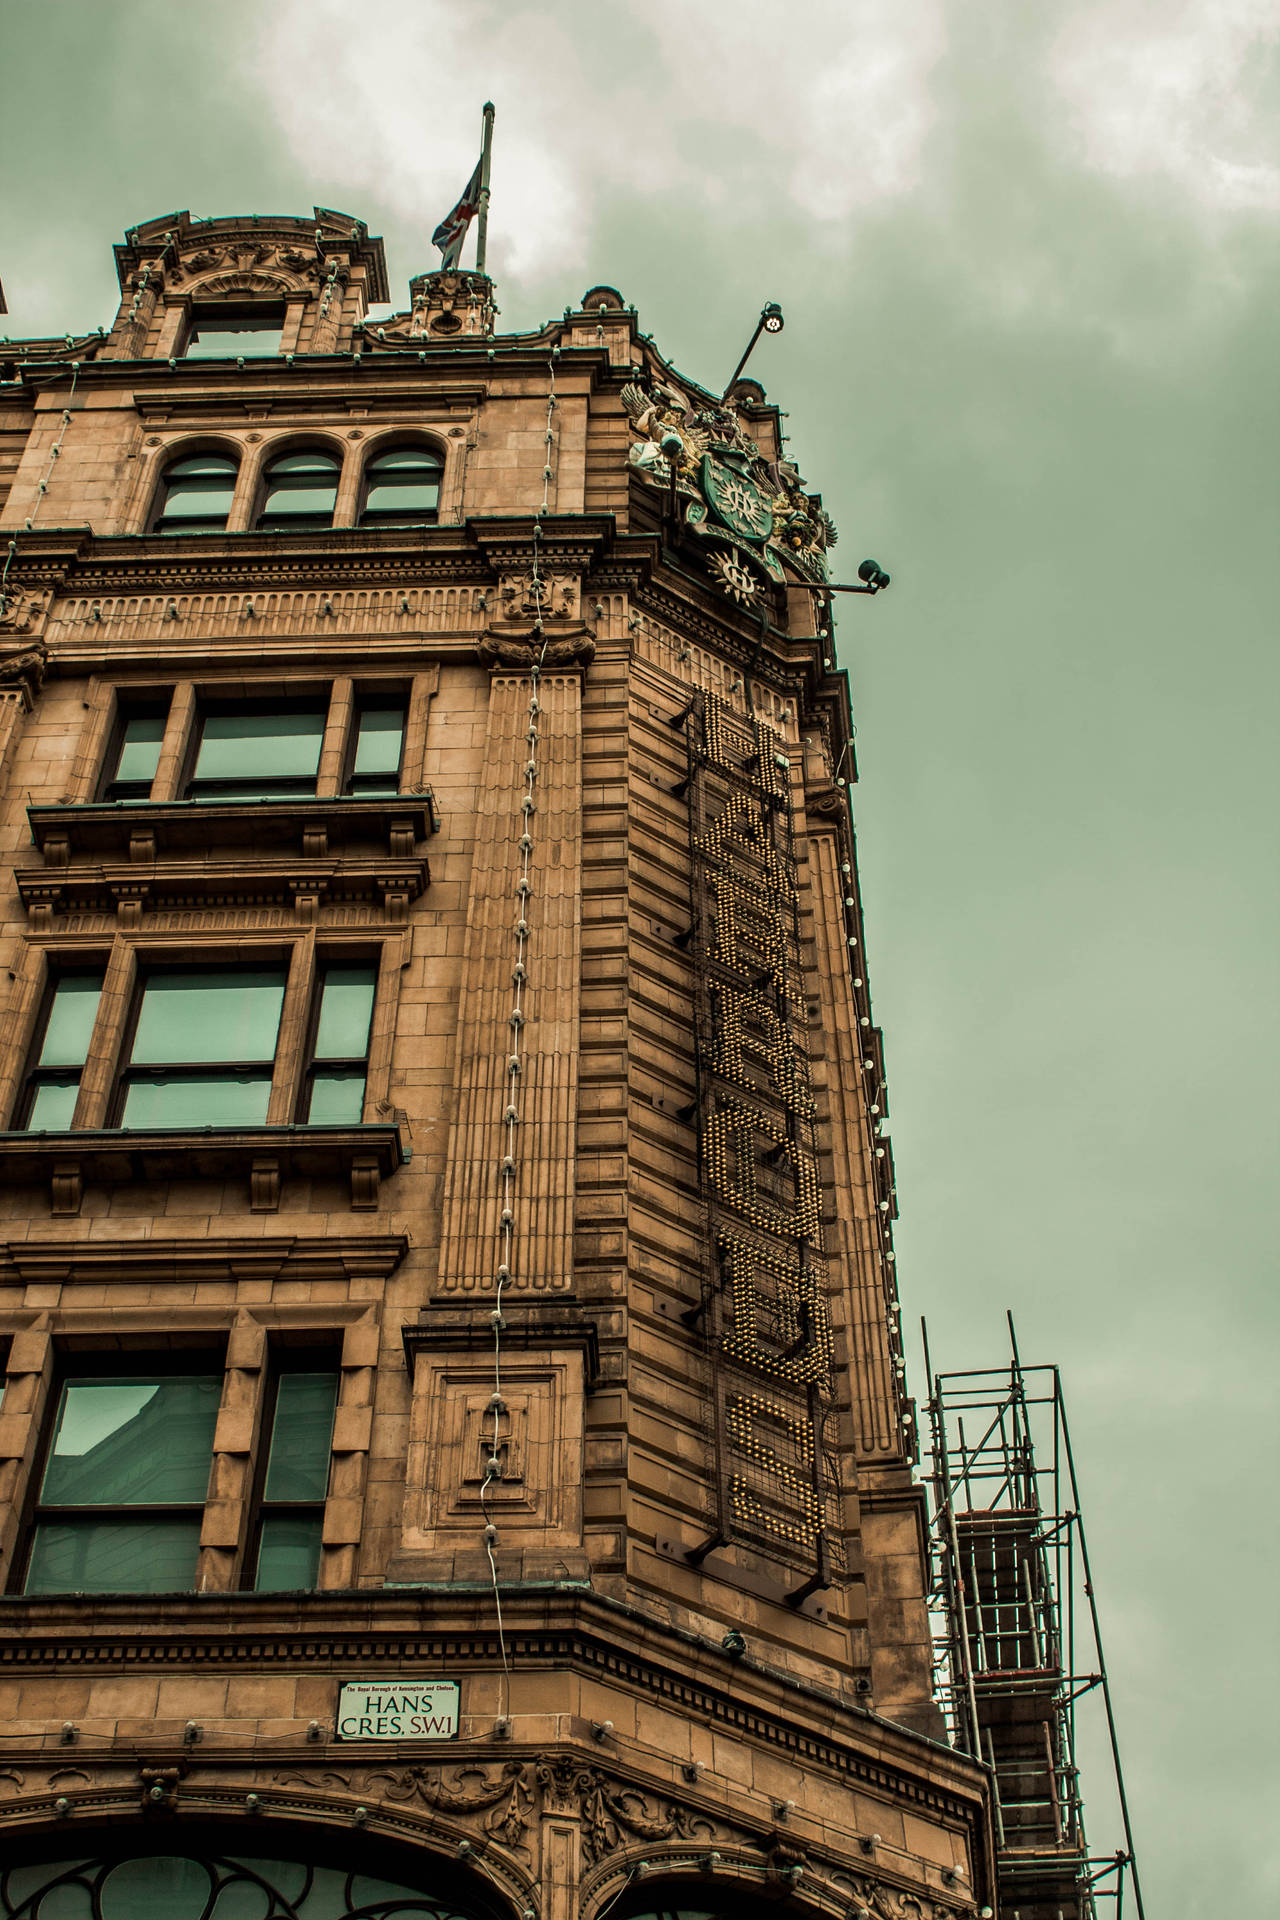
[480,346,560,1728]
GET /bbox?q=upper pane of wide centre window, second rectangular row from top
[132,968,284,1079]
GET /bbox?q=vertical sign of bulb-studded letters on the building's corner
[687,695,839,1590]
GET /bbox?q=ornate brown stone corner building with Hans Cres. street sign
[0,209,994,1920]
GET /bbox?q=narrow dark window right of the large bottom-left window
[244,1354,338,1594]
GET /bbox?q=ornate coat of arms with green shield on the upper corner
[622,376,837,605]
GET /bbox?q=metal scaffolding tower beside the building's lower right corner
[921,1315,1144,1920]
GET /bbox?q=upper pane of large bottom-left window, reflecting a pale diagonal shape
[40,1373,223,1507]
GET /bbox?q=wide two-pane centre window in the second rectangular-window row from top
[117,966,286,1127]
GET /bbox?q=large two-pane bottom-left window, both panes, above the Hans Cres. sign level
[25,1365,223,1594]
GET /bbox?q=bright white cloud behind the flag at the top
[246,0,946,278]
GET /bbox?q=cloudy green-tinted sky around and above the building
[0,0,1280,1920]
